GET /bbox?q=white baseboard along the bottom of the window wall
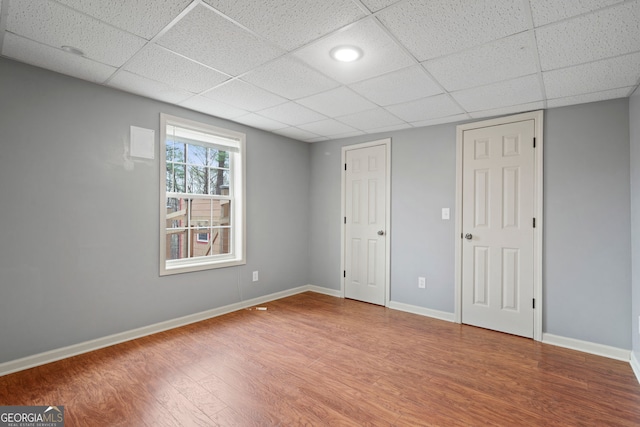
[0,285,316,377]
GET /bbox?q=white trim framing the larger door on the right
[454,110,544,341]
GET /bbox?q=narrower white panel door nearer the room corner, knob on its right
[344,145,387,305]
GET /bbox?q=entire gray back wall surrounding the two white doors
[310,99,631,349]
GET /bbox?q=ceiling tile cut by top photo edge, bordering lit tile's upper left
[205,0,365,50]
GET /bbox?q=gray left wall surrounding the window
[0,59,310,363]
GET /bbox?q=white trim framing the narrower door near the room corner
[340,138,391,307]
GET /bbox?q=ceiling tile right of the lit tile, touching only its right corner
[423,32,538,91]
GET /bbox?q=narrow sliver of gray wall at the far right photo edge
[629,90,640,360]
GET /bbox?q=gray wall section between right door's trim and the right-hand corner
[543,99,631,349]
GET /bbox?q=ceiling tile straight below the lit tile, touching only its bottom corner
[296,86,376,117]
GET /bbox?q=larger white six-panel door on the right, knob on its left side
[461,120,535,338]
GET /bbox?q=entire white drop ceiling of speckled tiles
[0,0,640,142]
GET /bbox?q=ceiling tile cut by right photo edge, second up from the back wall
[542,53,640,98]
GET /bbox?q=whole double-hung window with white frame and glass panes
[160,114,245,275]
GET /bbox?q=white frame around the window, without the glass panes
[160,113,247,276]
